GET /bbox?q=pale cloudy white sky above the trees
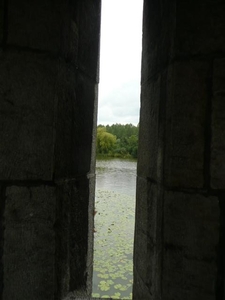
[98,0,143,125]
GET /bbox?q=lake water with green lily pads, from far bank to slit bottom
[92,159,136,299]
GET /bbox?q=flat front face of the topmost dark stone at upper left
[7,0,62,53]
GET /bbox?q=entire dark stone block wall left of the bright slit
[0,0,100,300]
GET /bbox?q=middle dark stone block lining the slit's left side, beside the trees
[55,64,97,178]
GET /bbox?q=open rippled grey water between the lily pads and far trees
[96,159,137,196]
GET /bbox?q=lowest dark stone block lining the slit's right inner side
[134,177,163,299]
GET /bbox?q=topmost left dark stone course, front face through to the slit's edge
[7,0,101,81]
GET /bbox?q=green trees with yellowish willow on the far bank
[97,124,139,158]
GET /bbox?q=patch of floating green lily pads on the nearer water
[92,190,135,299]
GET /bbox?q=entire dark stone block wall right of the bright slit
[134,0,225,300]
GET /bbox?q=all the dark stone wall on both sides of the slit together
[0,0,225,300]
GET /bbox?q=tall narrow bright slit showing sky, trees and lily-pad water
[92,0,143,299]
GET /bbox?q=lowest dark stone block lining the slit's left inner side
[56,176,91,298]
